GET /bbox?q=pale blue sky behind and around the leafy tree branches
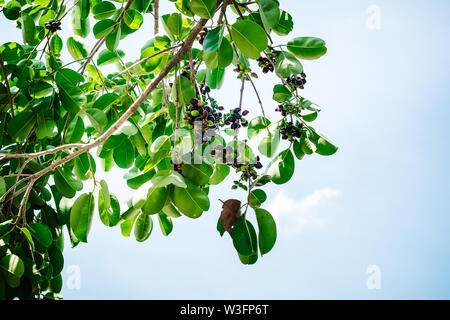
[0,0,450,299]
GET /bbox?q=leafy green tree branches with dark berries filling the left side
[0,0,337,299]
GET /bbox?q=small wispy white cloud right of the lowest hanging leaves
[267,188,340,234]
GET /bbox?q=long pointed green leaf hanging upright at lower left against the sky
[70,193,95,242]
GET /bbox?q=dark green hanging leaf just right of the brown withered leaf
[232,215,258,256]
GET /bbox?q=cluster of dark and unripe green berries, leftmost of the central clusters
[184,98,222,131]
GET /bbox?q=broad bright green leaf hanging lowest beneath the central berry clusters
[172,181,210,219]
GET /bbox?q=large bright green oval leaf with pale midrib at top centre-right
[231,20,268,59]
